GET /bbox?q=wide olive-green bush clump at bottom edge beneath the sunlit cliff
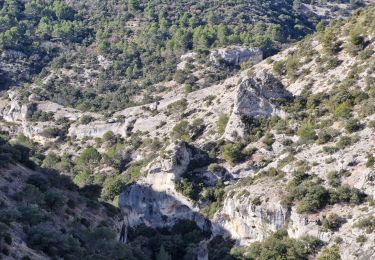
[246,230,320,260]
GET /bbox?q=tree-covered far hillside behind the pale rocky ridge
[0,0,359,111]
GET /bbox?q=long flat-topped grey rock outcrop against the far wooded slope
[210,47,263,66]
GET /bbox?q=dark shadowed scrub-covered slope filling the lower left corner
[0,133,238,260]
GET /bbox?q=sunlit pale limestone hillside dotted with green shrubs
[0,1,375,259]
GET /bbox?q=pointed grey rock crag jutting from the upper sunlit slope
[224,72,292,141]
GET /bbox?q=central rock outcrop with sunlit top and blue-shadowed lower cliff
[119,142,219,232]
